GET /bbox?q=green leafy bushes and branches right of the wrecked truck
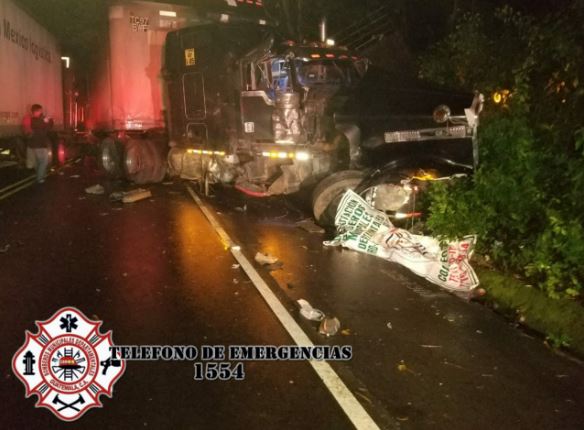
[420,3,584,297]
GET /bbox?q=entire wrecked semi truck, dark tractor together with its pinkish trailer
[92,0,483,224]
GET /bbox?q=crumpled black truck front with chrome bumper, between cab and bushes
[312,67,484,225]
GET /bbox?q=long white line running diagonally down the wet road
[187,185,379,430]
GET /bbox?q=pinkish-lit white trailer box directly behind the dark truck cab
[87,0,194,131]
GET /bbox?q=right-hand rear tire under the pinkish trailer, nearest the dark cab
[124,139,167,184]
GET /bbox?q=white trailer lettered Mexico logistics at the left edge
[0,0,64,163]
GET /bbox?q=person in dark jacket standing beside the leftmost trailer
[27,104,53,184]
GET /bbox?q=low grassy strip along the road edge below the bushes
[477,268,584,358]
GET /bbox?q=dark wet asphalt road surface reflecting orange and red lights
[0,162,584,429]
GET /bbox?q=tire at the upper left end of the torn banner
[312,170,365,227]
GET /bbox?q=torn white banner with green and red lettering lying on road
[325,190,479,291]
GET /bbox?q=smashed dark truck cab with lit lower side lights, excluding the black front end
[164,18,367,197]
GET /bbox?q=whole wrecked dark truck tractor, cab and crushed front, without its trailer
[157,10,482,225]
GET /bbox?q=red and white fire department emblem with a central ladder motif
[12,307,126,421]
